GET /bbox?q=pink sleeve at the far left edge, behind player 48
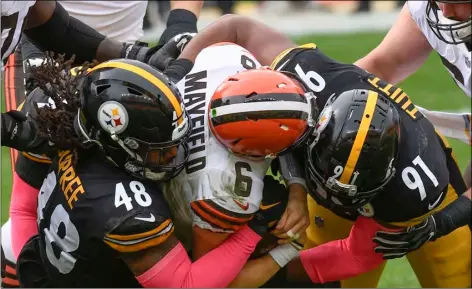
[10,173,39,258]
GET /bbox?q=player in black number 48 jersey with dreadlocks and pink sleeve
[17,58,274,288]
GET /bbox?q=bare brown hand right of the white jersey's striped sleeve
[273,184,310,244]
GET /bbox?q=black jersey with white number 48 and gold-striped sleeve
[38,151,174,288]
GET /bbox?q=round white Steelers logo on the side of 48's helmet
[97,100,129,134]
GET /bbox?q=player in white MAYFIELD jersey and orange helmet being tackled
[161,43,314,287]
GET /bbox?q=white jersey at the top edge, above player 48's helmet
[59,1,148,43]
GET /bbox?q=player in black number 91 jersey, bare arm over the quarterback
[166,16,471,287]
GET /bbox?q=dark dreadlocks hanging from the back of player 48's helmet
[31,52,96,149]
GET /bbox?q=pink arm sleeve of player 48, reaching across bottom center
[136,227,261,288]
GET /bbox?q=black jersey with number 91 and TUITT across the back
[271,44,465,222]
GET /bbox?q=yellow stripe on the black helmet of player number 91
[339,91,379,184]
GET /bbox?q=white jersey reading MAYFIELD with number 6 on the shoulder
[165,44,270,232]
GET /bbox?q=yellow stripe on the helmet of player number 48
[90,61,183,124]
